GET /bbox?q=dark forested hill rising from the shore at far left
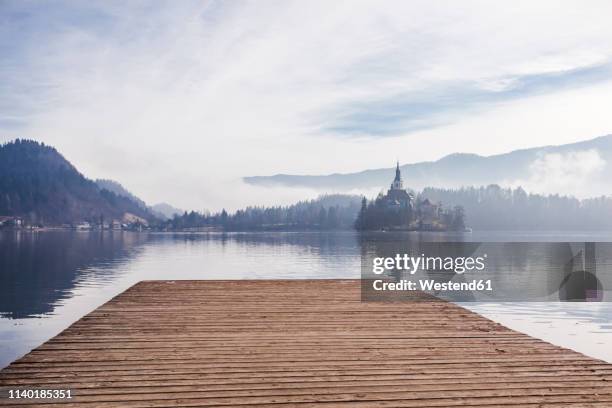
[0,140,154,225]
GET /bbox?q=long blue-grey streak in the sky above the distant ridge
[328,62,612,137]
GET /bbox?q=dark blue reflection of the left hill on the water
[0,231,147,318]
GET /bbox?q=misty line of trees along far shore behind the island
[163,185,612,231]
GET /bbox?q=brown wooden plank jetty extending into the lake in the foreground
[0,280,612,408]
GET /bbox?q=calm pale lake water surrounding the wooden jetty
[0,231,612,367]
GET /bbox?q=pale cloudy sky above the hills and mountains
[0,0,612,209]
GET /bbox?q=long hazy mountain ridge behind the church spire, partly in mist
[244,135,612,195]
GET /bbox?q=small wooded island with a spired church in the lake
[355,161,465,231]
